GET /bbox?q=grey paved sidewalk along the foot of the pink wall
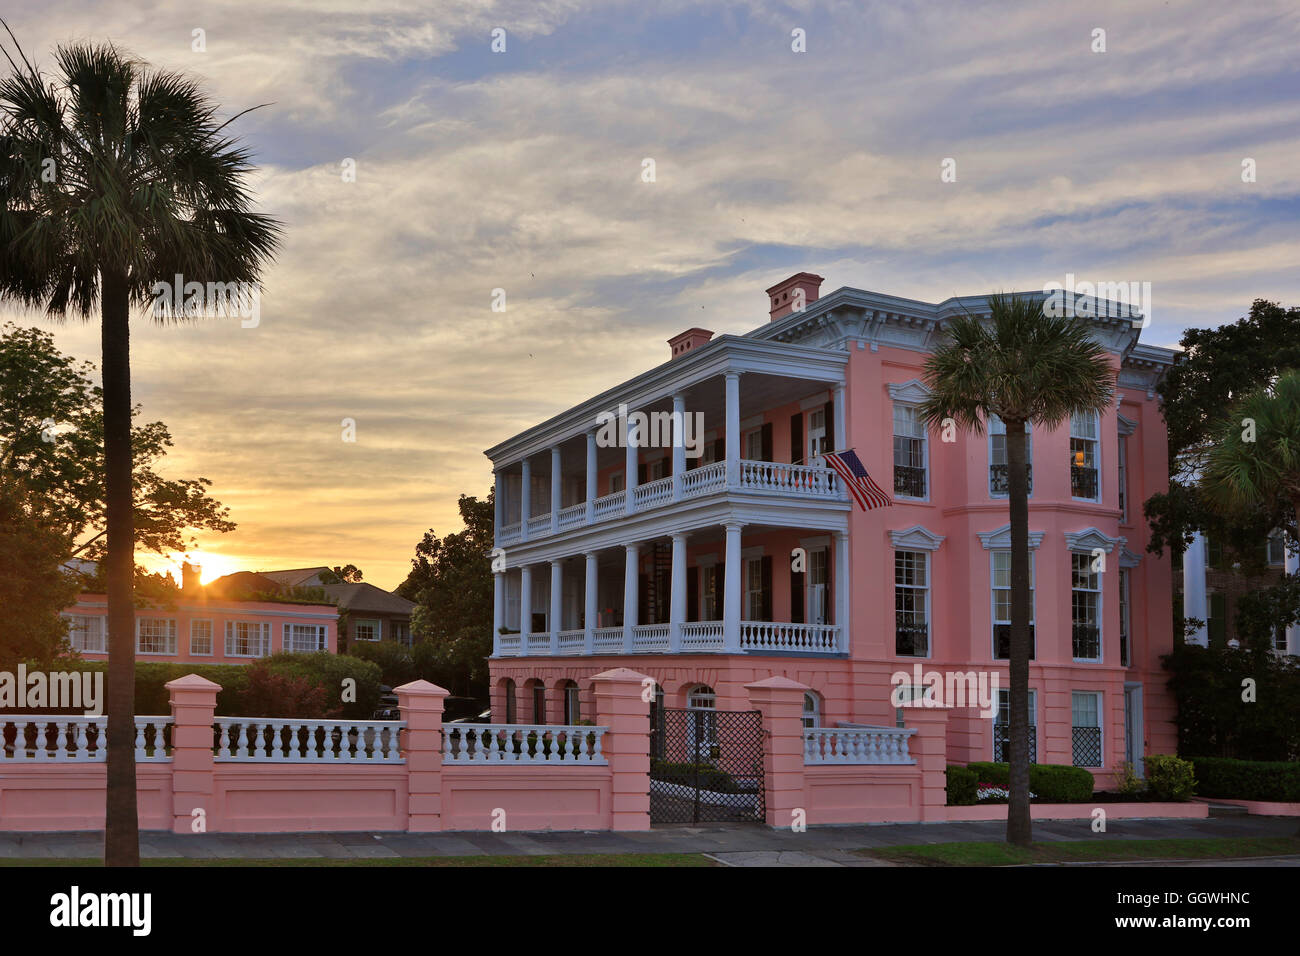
[0,817,1300,866]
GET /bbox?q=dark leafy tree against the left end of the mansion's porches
[397,492,494,696]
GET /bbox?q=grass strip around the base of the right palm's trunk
[855,836,1300,866]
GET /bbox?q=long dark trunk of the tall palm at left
[100,272,140,866]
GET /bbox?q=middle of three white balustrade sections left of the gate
[212,717,406,763]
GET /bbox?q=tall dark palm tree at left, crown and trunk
[0,31,280,866]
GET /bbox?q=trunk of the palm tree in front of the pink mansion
[1006,420,1034,847]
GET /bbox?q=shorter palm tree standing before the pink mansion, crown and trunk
[922,295,1113,847]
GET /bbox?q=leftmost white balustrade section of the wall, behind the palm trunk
[0,714,172,763]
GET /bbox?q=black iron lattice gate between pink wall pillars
[650,708,764,823]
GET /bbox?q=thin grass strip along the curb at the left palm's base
[0,853,718,866]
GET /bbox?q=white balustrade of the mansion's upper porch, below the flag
[497,459,842,546]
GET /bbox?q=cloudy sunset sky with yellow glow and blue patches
[0,0,1300,588]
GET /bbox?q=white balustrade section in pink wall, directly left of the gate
[442,723,608,765]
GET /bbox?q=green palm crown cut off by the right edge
[1201,369,1300,564]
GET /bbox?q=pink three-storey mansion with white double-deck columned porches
[486,273,1175,784]
